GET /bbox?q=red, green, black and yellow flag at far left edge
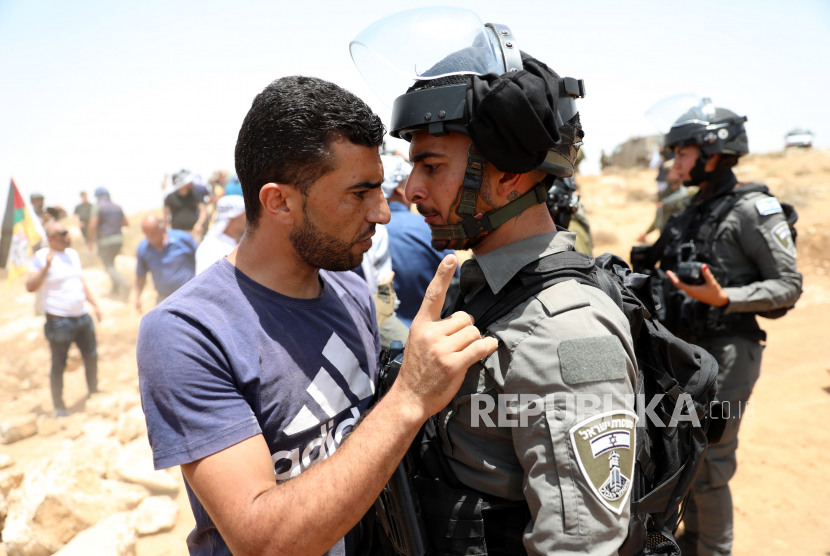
[0,180,43,283]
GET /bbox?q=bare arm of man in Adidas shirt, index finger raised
[182,257,497,555]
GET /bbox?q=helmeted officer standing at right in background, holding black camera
[646,97,801,556]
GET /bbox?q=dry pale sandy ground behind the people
[0,150,830,556]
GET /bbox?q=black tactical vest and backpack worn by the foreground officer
[372,251,724,556]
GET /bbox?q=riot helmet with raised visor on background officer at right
[646,94,749,185]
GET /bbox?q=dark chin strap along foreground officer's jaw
[430,145,548,250]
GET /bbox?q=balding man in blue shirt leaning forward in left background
[135,214,197,313]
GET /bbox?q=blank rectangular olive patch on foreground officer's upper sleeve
[558,336,626,385]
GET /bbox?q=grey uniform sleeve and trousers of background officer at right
[672,188,802,556]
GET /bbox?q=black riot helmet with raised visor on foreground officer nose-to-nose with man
[349,8,585,249]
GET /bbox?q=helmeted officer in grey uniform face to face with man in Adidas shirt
[351,8,637,555]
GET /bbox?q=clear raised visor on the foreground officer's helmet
[349,7,508,108]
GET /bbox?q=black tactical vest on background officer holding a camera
[656,178,798,343]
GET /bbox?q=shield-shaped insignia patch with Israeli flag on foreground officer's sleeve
[570,410,637,514]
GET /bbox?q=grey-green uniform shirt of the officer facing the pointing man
[439,232,637,556]
